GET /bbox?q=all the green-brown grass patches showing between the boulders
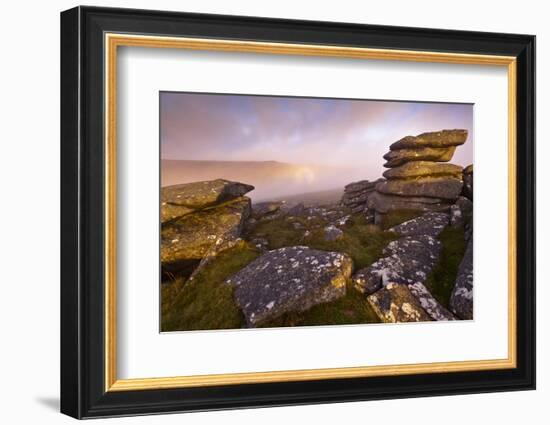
[161,211,448,331]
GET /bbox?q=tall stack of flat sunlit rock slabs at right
[367,130,468,221]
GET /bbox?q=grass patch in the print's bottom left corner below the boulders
[161,241,259,332]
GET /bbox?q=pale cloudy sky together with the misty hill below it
[160,92,473,199]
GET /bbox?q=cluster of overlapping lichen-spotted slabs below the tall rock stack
[352,213,455,322]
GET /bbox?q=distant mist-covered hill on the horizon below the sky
[161,159,361,203]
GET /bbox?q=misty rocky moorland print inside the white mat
[159,91,474,332]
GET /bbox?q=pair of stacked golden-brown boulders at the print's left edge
[160,179,254,275]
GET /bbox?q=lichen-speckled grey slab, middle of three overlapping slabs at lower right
[353,235,441,294]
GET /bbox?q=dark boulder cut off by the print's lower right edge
[449,239,474,320]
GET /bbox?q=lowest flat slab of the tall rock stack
[367,192,451,214]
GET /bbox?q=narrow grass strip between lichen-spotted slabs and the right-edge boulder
[426,226,466,308]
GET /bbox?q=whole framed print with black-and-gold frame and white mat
[61,7,535,418]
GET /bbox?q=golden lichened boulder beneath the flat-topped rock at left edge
[160,197,250,266]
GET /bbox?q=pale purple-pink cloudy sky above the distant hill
[160,92,473,174]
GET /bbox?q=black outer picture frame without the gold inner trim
[61,7,535,418]
